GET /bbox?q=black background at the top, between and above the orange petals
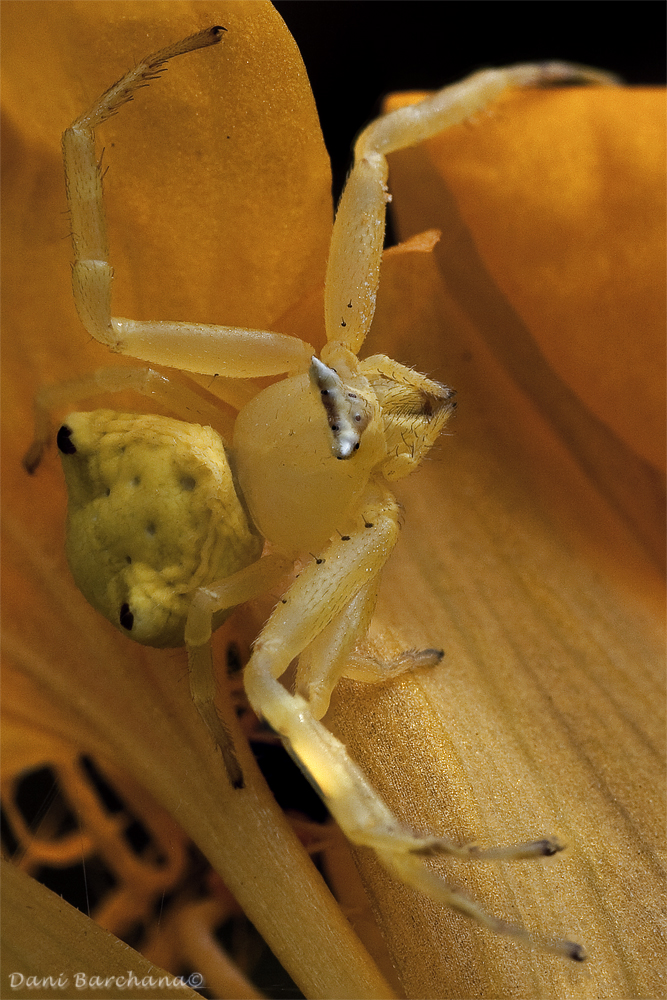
[274,0,666,205]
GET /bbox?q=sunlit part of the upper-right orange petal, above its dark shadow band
[394,88,665,469]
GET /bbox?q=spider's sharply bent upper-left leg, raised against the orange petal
[63,27,312,378]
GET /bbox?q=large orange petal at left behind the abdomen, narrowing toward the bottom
[2,2,391,997]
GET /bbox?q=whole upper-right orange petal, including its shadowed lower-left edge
[393,88,665,566]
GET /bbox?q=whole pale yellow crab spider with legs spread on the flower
[26,27,608,960]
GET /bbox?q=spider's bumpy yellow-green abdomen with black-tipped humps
[60,410,262,646]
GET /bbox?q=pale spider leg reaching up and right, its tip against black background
[325,63,617,354]
